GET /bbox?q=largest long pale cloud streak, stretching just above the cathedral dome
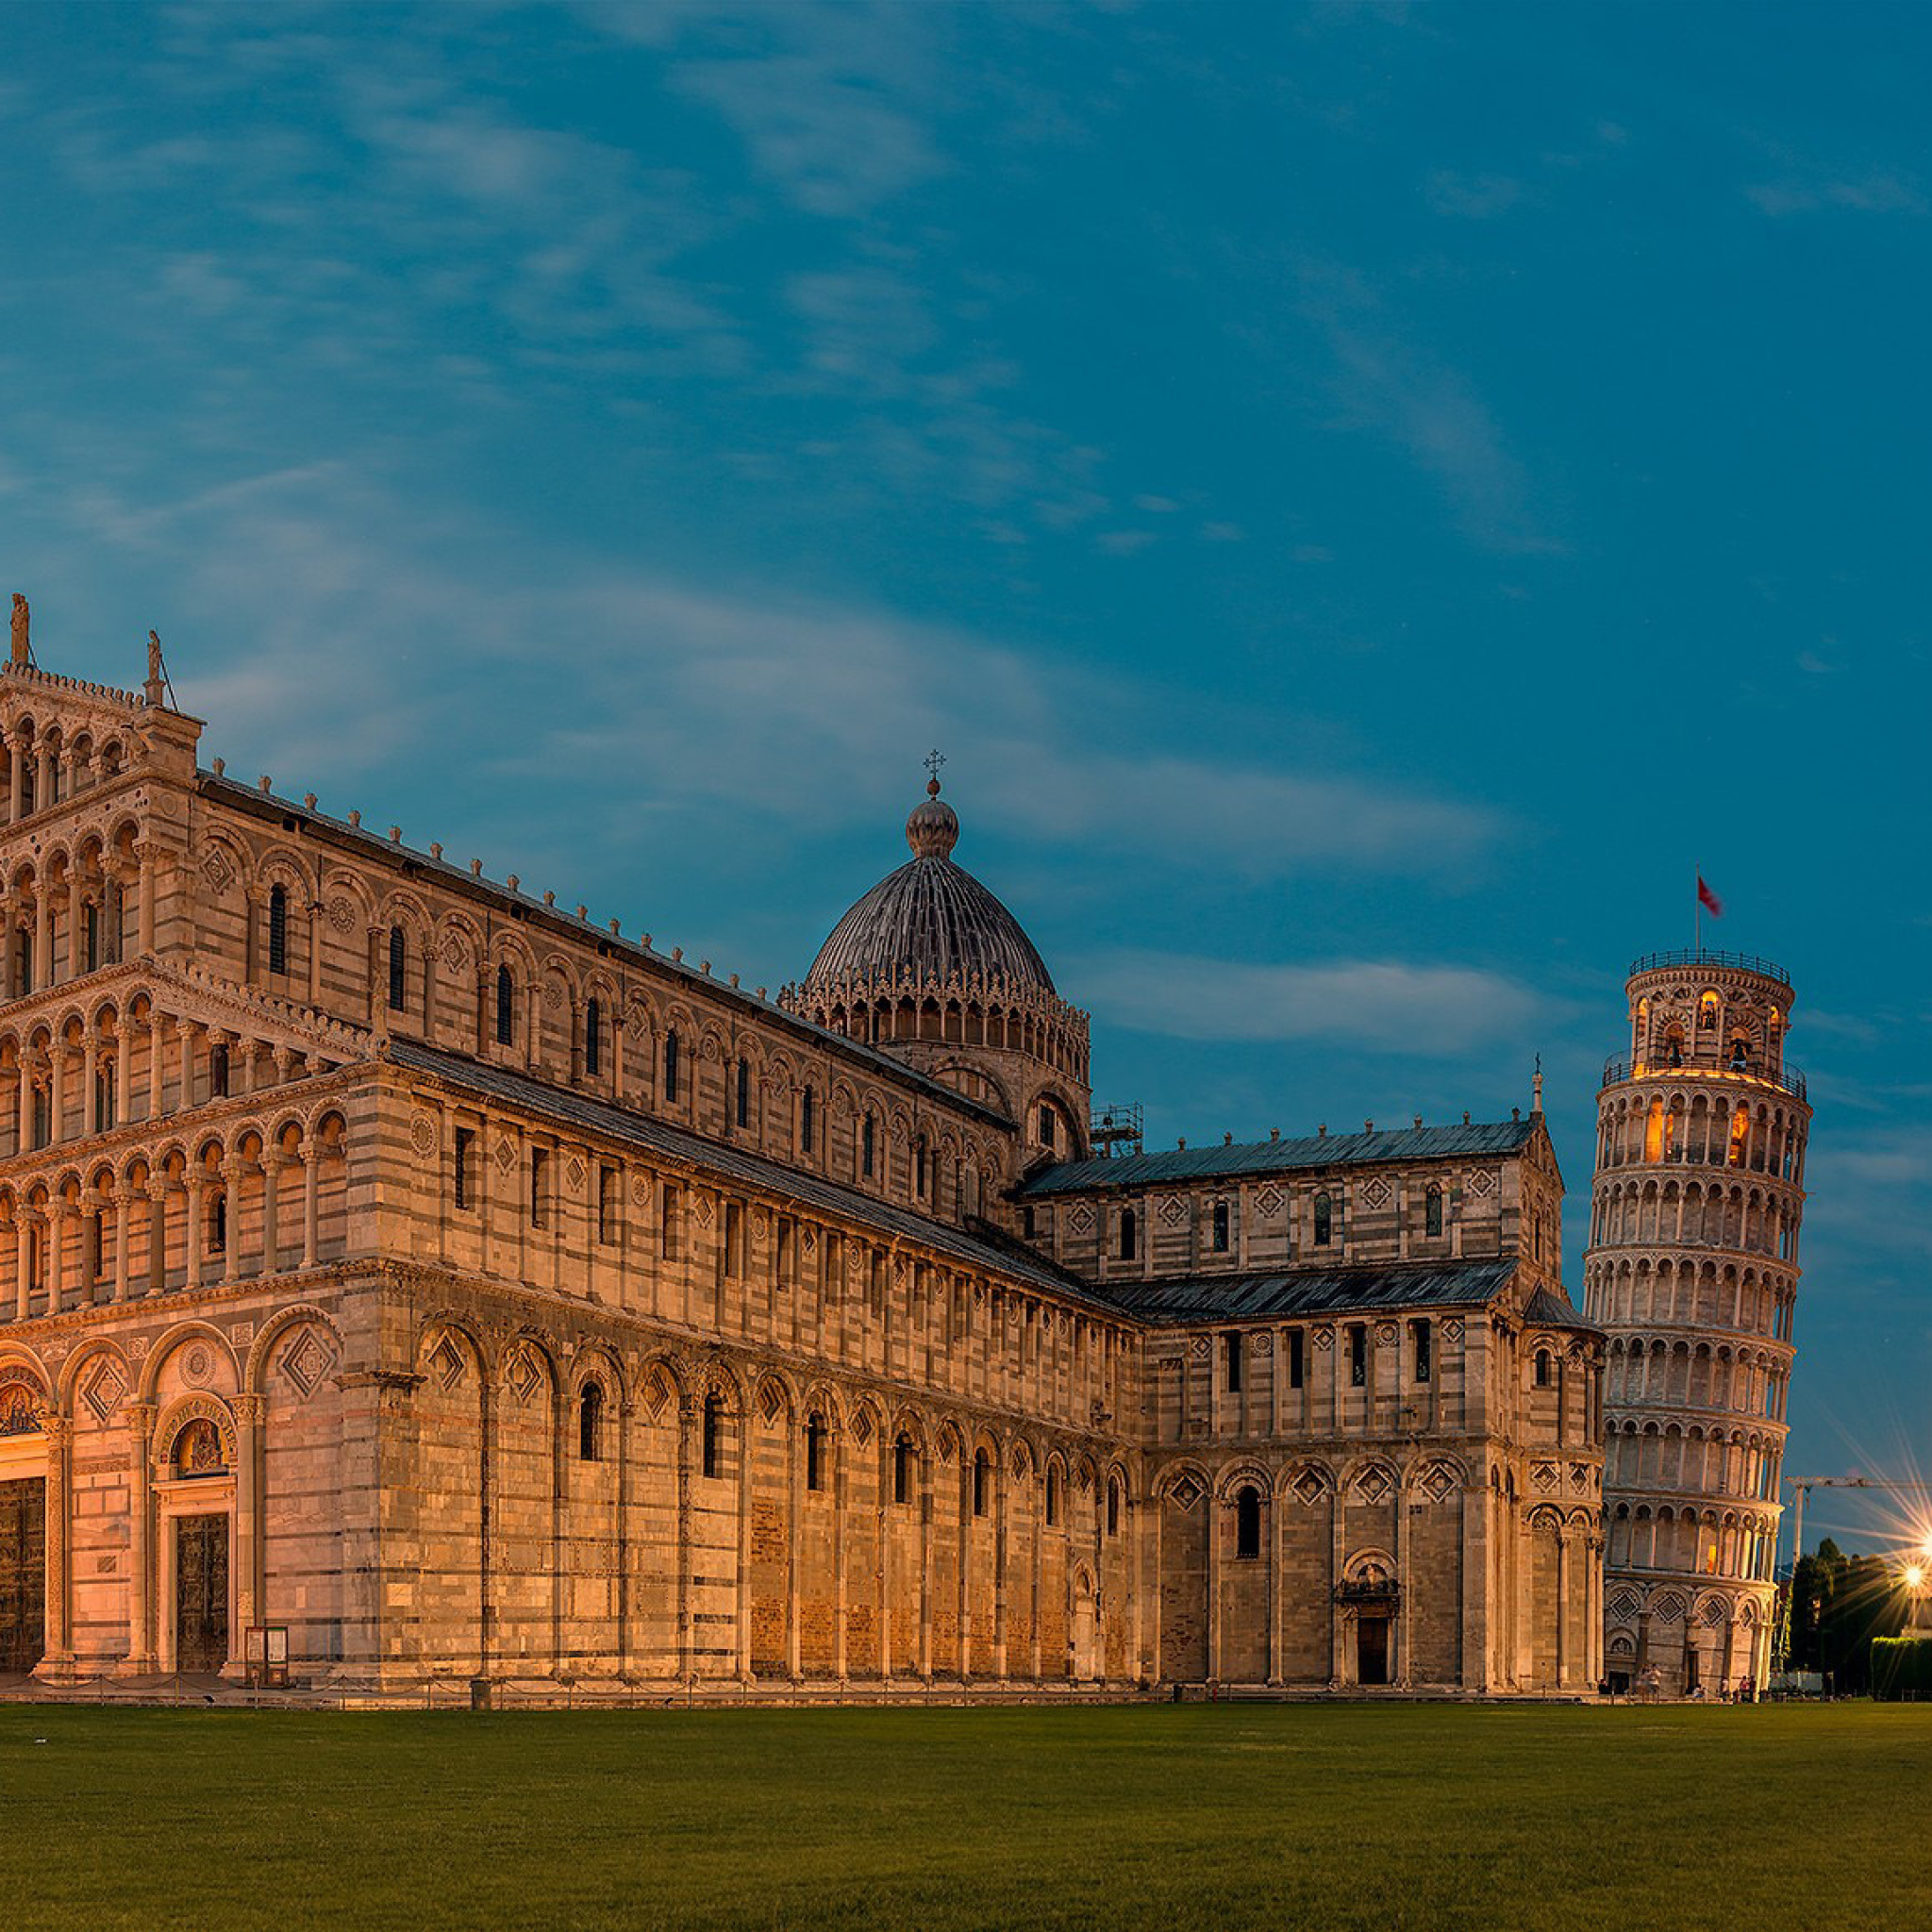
[75,466,1511,881]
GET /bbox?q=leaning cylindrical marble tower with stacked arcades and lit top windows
[1584,949,1810,1696]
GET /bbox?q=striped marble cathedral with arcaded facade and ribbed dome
[0,605,1795,1698]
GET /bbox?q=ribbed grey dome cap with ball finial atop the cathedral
[804,778,1055,997]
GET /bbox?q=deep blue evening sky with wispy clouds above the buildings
[0,0,1932,1528]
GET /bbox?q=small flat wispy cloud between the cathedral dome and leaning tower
[1078,953,1545,1058]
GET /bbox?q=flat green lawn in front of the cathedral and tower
[0,1704,1932,1932]
